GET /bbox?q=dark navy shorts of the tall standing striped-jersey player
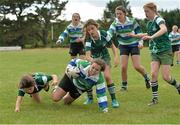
[119,45,140,56]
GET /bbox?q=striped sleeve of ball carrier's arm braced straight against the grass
[96,73,108,110]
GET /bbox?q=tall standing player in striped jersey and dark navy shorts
[108,6,150,91]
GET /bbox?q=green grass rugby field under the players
[0,48,180,124]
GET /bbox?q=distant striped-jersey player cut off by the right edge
[169,25,180,64]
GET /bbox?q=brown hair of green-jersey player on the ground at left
[19,75,35,89]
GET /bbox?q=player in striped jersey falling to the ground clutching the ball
[52,59,108,112]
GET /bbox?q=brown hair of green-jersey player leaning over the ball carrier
[83,19,99,39]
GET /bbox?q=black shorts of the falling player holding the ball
[58,74,81,99]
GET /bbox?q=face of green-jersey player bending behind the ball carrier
[86,25,98,38]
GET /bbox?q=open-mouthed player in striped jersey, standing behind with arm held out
[56,13,85,59]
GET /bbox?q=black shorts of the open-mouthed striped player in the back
[69,42,85,56]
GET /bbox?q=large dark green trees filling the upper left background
[0,0,68,47]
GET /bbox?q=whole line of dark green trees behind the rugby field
[0,0,180,48]
